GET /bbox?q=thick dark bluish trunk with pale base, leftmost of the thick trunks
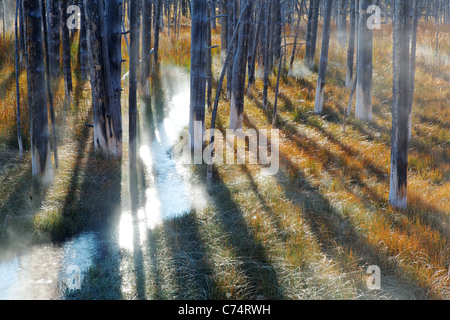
[23,0,53,185]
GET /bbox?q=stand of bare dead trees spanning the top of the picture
[0,0,450,212]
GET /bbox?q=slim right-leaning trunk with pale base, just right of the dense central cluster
[314,0,333,114]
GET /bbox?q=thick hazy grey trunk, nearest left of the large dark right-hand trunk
[355,0,373,121]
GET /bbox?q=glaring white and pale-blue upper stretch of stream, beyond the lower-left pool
[119,67,207,251]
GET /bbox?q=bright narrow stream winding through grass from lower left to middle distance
[0,66,207,300]
